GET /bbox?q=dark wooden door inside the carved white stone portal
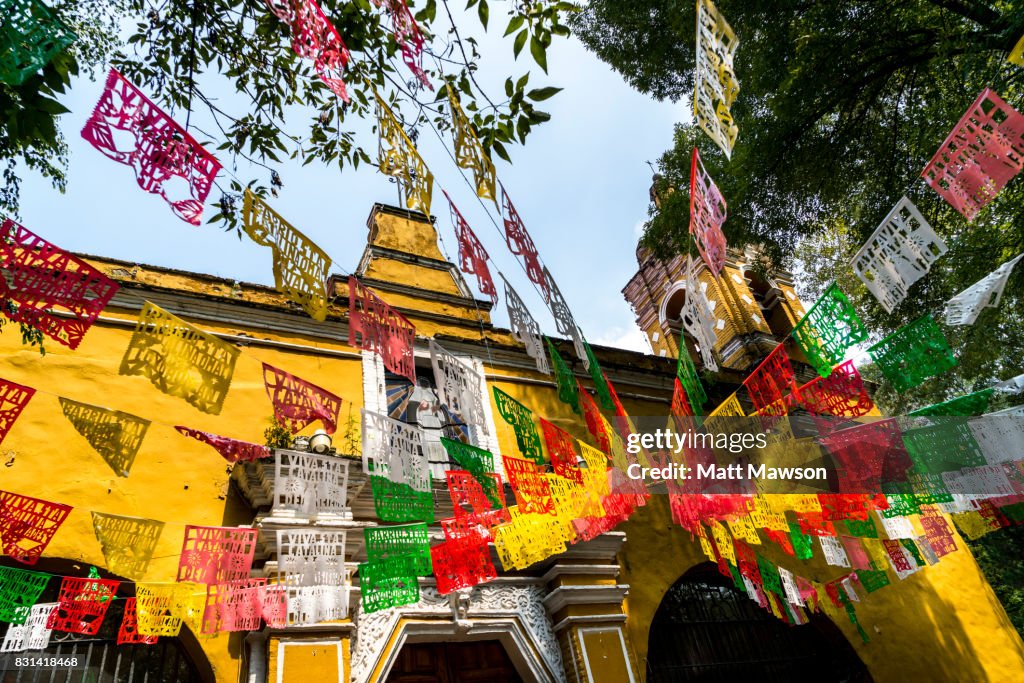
[387,640,522,683]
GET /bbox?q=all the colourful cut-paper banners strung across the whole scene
[6,0,1024,651]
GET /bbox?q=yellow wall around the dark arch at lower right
[620,496,1024,683]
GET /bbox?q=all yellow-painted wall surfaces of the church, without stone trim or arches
[8,206,1024,683]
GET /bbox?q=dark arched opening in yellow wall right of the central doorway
[647,562,871,683]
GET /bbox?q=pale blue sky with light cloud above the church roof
[14,6,689,352]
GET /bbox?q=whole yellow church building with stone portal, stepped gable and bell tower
[0,205,1024,683]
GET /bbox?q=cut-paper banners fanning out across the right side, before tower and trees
[638,22,1024,618]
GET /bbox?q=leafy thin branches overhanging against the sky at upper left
[0,0,572,226]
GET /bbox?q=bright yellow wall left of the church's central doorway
[0,260,362,681]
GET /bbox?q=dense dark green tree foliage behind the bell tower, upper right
[570,0,1024,402]
